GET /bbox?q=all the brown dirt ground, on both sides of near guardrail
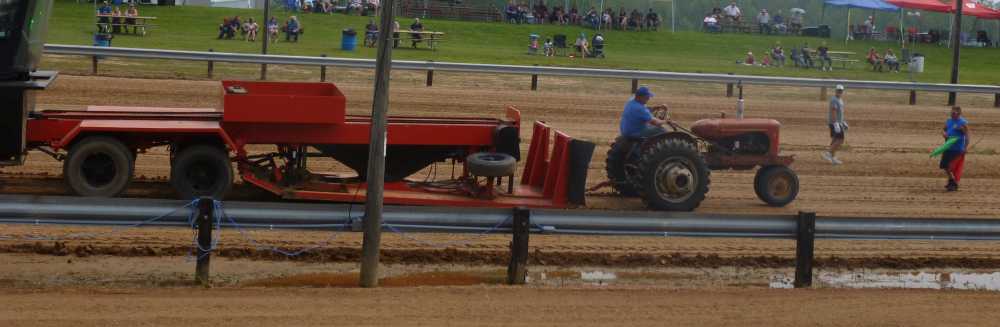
[0,68,1000,326]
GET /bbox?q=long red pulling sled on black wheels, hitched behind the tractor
[26,81,594,208]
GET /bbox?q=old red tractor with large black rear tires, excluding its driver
[606,113,799,211]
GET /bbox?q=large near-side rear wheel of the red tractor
[636,138,711,211]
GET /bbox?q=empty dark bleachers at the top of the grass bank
[401,0,503,22]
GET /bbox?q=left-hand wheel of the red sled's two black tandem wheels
[63,136,135,197]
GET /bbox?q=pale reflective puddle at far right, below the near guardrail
[770,271,1000,291]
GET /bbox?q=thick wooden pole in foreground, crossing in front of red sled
[361,0,395,287]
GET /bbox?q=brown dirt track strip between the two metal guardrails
[0,72,1000,217]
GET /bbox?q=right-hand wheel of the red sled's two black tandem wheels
[170,145,233,200]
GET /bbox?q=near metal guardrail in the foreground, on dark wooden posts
[0,195,1000,240]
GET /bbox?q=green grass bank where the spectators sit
[48,0,1000,85]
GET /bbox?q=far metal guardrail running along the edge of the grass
[45,44,1000,95]
